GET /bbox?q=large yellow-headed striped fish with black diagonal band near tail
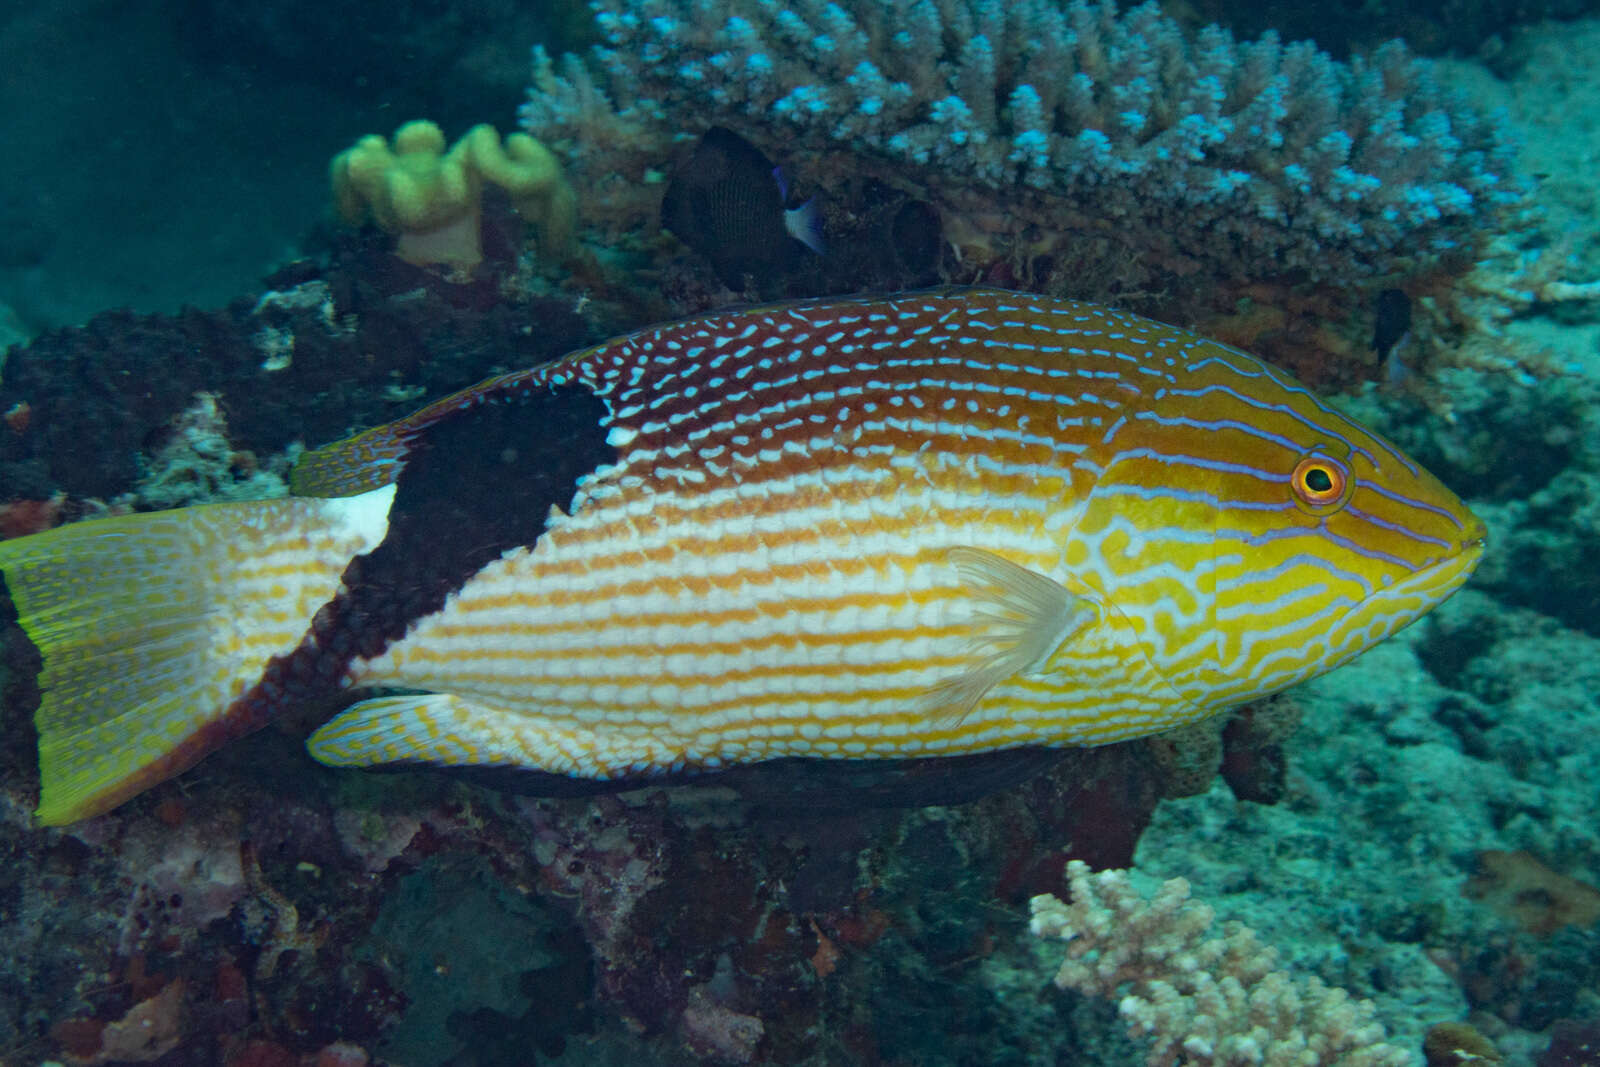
[0,288,1485,824]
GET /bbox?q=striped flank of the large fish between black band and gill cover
[358,298,1154,773]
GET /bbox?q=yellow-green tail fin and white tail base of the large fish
[0,486,394,825]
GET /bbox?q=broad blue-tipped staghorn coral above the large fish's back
[522,0,1520,303]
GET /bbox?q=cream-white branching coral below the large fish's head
[1029,861,1413,1067]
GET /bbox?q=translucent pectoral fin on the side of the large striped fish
[928,547,1099,721]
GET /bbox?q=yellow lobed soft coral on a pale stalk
[330,122,578,269]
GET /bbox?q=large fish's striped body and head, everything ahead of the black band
[341,290,1475,776]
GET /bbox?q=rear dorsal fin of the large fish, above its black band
[290,350,587,496]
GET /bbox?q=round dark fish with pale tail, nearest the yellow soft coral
[661,126,822,290]
